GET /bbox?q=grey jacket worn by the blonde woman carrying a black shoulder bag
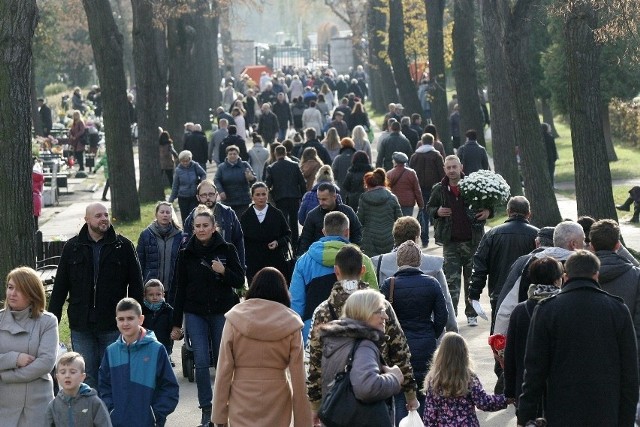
[320,319,401,427]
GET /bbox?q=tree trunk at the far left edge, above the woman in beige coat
[0,0,38,294]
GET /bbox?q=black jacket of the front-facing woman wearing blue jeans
[173,231,244,327]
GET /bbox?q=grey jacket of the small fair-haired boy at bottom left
[46,383,111,427]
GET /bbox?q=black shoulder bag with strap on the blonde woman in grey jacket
[318,340,392,427]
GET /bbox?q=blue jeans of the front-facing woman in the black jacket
[184,313,225,408]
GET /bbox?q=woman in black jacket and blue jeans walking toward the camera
[171,205,244,425]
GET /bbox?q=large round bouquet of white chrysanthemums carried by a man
[458,169,510,211]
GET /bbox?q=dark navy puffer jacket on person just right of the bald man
[136,221,182,294]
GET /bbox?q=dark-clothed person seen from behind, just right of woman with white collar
[265,146,307,248]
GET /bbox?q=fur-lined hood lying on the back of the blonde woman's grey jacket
[318,319,386,358]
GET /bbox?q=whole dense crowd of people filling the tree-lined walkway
[8,69,640,427]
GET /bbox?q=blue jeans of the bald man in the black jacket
[71,329,120,389]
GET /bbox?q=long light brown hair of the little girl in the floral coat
[423,332,475,397]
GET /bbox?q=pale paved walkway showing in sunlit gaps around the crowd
[40,139,640,427]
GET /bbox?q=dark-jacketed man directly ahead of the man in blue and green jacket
[298,182,362,255]
